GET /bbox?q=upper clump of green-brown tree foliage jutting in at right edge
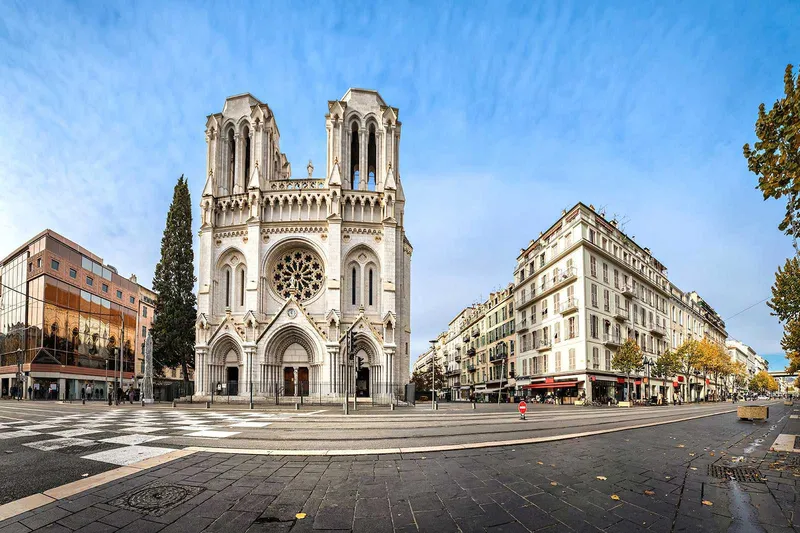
[743,64,800,245]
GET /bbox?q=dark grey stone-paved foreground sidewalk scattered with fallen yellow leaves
[0,406,800,533]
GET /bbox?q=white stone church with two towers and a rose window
[195,89,412,402]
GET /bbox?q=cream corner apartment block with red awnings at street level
[514,203,727,403]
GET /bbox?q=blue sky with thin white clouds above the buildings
[0,0,800,369]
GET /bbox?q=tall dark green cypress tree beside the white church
[153,175,197,382]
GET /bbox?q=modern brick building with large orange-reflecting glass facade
[0,230,140,399]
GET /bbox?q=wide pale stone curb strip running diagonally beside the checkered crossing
[0,449,194,522]
